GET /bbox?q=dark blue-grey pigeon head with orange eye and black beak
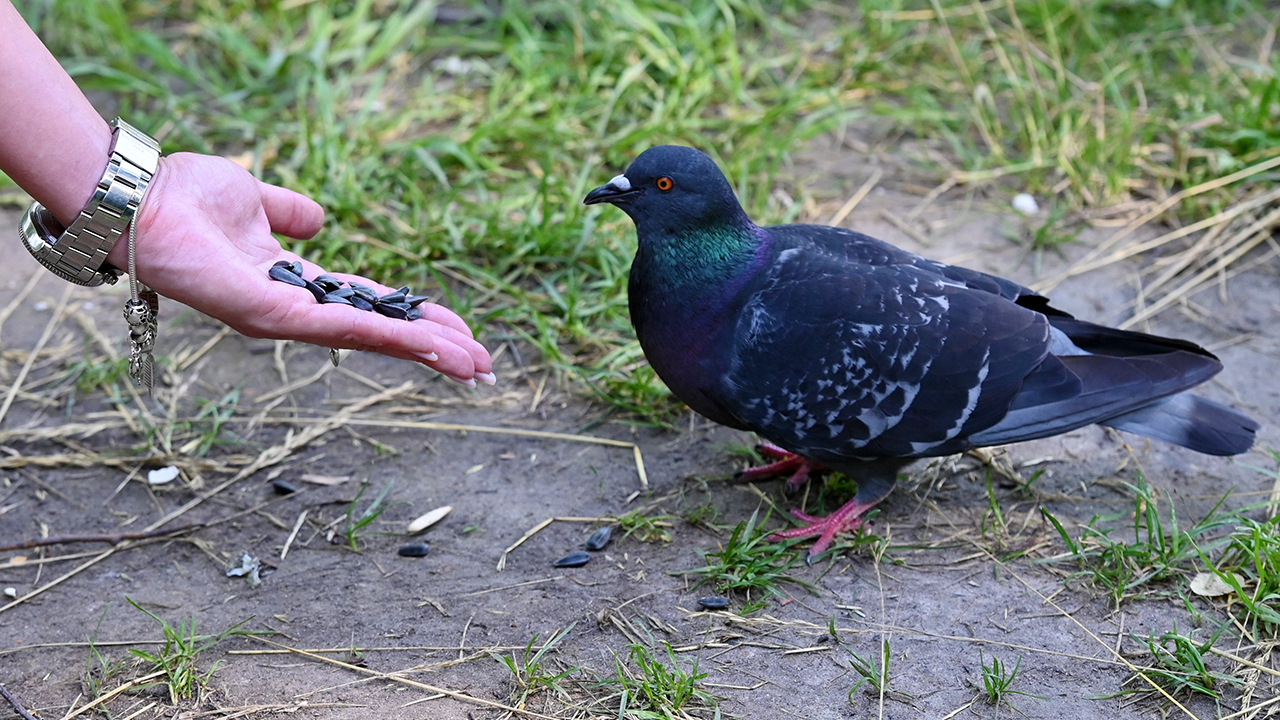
[582,145,750,237]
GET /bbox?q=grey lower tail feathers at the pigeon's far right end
[1102,392,1258,455]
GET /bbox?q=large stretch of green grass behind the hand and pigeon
[19,0,1280,421]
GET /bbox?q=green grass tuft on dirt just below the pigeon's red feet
[672,510,813,614]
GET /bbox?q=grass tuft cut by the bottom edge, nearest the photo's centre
[603,642,719,720]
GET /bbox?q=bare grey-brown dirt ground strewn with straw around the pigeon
[0,133,1280,719]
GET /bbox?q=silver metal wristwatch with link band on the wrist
[18,118,160,286]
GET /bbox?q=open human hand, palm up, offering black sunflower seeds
[106,152,495,387]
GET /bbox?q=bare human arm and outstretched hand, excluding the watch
[0,0,494,384]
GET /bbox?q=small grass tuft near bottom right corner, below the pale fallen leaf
[1110,625,1240,701]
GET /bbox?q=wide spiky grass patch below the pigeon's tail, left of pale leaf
[1042,473,1238,607]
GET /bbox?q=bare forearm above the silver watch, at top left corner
[0,0,111,225]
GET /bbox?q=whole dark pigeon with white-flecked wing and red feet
[584,145,1258,562]
